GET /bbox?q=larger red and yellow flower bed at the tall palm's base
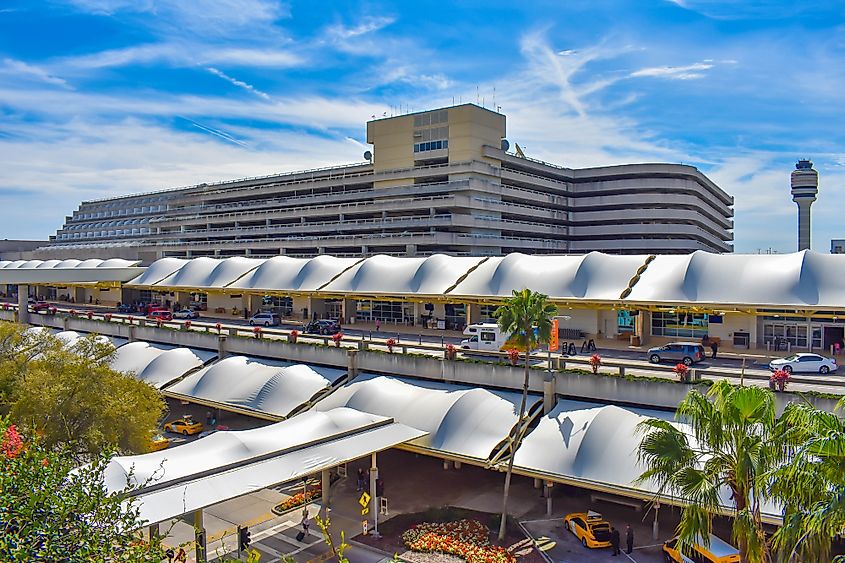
[402,520,516,563]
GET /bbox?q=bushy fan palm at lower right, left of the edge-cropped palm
[638,380,785,563]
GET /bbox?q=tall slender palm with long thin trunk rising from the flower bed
[493,289,557,541]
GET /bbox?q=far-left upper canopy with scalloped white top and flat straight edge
[0,258,144,284]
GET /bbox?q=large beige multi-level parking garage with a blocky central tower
[37,104,733,261]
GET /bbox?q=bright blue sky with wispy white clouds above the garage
[0,0,845,252]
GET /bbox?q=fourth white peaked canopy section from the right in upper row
[229,256,359,293]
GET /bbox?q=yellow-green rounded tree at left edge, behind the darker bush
[0,323,165,459]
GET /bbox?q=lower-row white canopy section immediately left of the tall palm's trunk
[314,375,539,460]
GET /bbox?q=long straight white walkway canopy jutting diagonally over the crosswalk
[104,409,424,523]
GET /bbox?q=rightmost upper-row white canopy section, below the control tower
[626,250,845,308]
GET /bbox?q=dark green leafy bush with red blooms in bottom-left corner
[0,418,164,563]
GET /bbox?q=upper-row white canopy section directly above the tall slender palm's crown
[449,252,647,301]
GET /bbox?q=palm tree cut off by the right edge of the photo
[770,399,845,561]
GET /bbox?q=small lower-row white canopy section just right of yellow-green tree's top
[111,342,217,389]
